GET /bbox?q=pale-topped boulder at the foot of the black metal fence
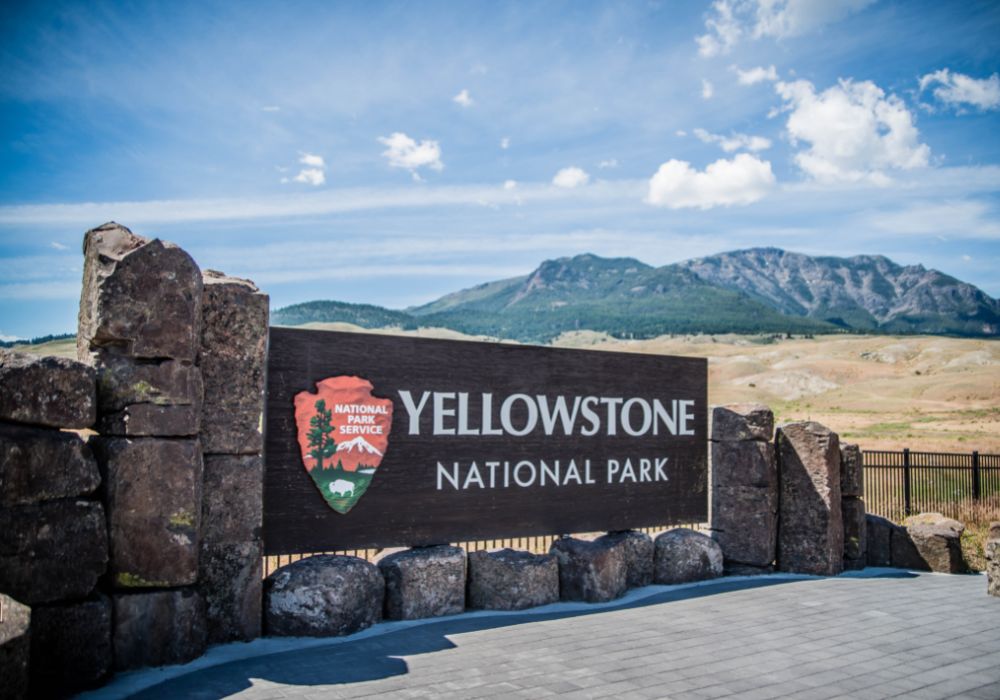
[892,513,966,574]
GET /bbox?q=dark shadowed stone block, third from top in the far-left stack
[0,500,108,605]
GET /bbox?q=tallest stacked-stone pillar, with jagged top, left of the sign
[77,223,205,669]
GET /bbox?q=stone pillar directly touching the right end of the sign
[710,404,778,574]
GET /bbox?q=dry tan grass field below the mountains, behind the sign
[24,323,1000,453]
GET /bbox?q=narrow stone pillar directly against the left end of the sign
[193,270,268,643]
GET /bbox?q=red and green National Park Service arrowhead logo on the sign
[295,375,392,513]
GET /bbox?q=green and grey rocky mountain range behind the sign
[272,248,1000,342]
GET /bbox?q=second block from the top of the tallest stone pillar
[97,356,204,437]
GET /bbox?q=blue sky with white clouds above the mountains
[0,0,1000,337]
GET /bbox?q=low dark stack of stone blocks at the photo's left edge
[0,351,111,697]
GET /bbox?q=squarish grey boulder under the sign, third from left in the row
[467,549,559,610]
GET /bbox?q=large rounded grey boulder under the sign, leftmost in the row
[264,554,385,637]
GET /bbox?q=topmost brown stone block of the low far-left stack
[0,349,97,428]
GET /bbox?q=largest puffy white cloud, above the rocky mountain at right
[775,80,930,184]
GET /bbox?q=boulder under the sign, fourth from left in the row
[549,537,628,603]
